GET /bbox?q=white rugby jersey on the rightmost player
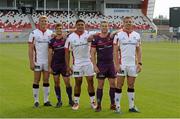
[114,31,141,66]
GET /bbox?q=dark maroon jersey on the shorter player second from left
[49,38,65,66]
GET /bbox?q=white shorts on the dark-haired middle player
[73,63,95,77]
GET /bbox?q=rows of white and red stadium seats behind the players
[0,10,153,30]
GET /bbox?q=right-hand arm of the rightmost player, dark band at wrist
[136,39,142,73]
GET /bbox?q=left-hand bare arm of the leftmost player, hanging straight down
[28,43,35,71]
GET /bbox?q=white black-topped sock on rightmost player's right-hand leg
[127,88,135,109]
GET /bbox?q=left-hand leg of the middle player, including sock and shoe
[72,77,82,110]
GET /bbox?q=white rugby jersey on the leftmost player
[28,29,53,63]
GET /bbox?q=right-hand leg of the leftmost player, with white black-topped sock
[43,71,52,106]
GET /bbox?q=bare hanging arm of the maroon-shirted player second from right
[90,47,99,73]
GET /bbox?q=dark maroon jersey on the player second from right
[91,33,113,64]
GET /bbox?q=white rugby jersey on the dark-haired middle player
[65,31,91,66]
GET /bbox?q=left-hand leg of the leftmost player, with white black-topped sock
[33,71,41,108]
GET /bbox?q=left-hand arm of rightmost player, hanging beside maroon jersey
[113,36,120,72]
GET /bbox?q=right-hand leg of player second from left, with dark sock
[63,76,74,106]
